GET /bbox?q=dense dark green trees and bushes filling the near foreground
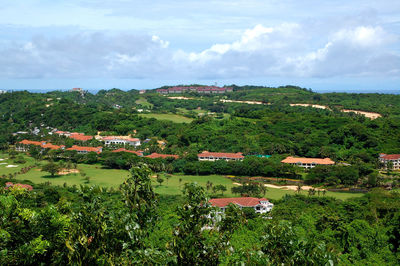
[0,165,400,265]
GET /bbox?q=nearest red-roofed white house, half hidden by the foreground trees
[209,197,274,213]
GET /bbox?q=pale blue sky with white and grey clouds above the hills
[0,0,400,93]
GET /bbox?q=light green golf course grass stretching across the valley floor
[0,153,363,199]
